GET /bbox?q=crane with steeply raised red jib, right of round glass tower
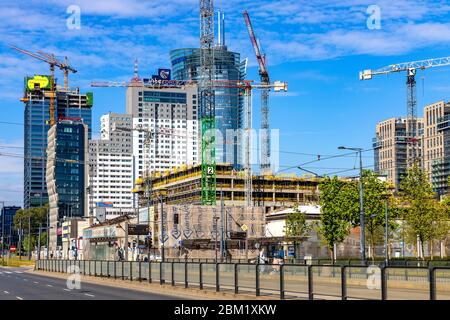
[243,11,270,175]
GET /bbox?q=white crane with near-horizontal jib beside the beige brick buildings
[359,57,450,161]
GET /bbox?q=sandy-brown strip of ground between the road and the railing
[29,269,279,300]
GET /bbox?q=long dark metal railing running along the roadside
[35,260,450,300]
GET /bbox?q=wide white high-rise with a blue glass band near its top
[126,85,201,178]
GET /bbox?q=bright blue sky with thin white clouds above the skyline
[0,0,450,205]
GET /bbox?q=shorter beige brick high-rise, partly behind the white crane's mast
[373,118,423,189]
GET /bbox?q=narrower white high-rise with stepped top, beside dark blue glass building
[89,112,134,218]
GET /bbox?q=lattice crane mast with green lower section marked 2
[199,0,216,205]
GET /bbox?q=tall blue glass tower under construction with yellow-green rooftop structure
[22,75,92,208]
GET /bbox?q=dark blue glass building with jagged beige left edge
[46,120,88,250]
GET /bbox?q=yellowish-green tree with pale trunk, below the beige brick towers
[400,164,448,258]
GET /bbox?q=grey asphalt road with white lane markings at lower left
[0,267,183,300]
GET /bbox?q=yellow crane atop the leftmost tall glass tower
[10,46,77,126]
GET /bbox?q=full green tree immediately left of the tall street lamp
[316,177,355,261]
